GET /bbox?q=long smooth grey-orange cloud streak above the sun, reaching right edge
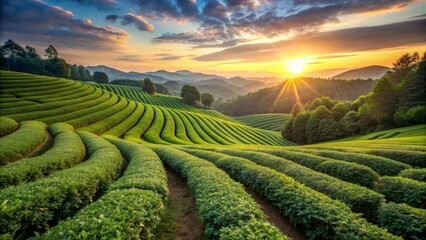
[195,19,426,62]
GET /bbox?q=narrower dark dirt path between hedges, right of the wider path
[245,187,306,240]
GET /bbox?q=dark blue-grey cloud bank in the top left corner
[0,0,128,50]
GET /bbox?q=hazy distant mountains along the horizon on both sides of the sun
[86,65,390,99]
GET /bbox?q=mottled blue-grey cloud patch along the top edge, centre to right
[146,0,416,47]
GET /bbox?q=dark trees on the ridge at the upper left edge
[0,39,108,83]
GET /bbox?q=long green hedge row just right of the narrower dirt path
[186,149,399,240]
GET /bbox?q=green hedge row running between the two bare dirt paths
[151,146,288,239]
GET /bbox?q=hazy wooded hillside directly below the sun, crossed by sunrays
[213,77,376,116]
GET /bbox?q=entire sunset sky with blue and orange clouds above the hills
[0,0,426,77]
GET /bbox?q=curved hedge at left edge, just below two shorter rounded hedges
[0,124,86,188]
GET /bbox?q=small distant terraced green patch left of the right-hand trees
[234,113,291,131]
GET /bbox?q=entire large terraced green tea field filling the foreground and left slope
[0,71,426,240]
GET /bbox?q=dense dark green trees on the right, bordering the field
[282,53,426,144]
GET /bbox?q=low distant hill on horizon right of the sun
[332,65,391,80]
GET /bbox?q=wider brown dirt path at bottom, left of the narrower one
[155,167,207,240]
